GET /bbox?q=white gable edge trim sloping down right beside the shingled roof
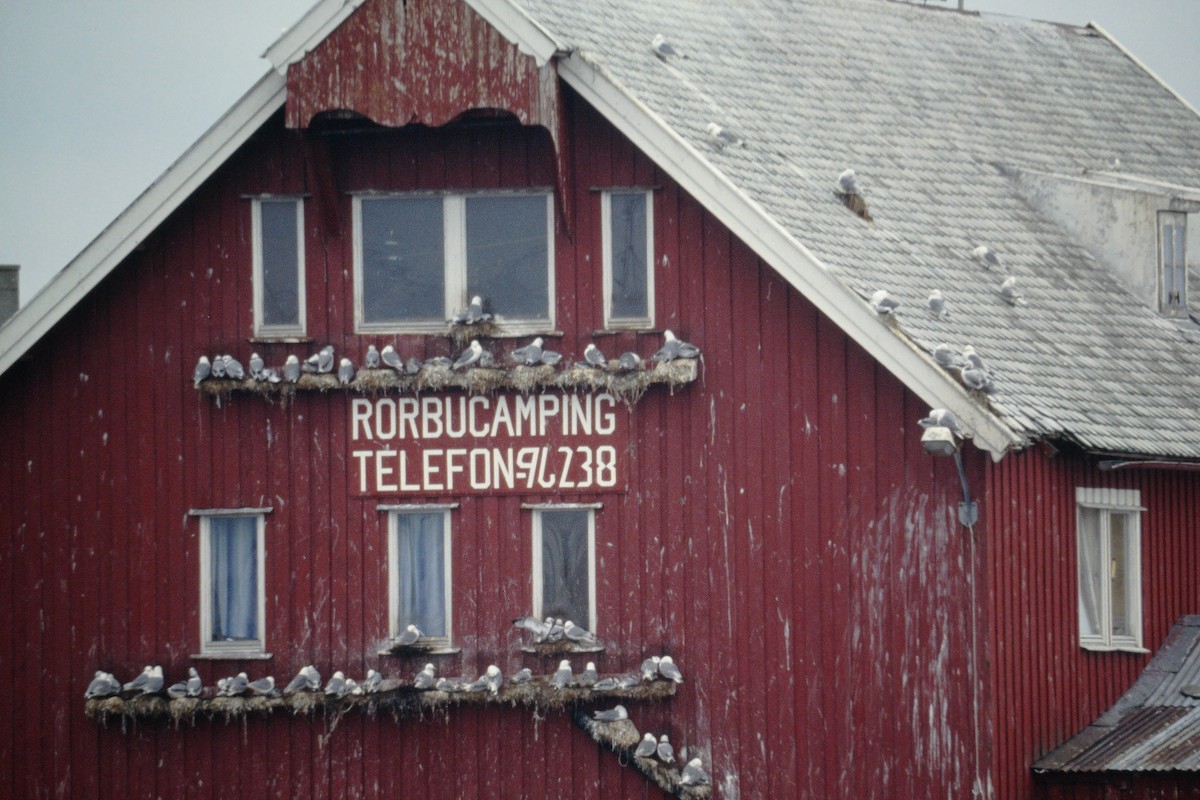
[558,53,1028,461]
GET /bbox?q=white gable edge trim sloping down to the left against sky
[0,71,287,375]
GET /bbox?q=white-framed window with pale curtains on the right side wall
[1075,488,1142,650]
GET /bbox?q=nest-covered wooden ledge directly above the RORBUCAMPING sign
[197,359,700,404]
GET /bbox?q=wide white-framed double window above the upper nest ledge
[354,192,554,333]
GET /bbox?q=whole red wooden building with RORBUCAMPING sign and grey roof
[7,0,1200,798]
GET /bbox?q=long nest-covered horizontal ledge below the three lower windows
[84,675,676,729]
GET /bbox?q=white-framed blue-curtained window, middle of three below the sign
[380,505,455,645]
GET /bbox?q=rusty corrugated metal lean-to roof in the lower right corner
[1033,616,1200,772]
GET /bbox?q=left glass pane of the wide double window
[361,197,445,323]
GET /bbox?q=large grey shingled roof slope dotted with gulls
[508,0,1200,458]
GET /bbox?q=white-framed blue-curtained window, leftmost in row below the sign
[192,509,270,658]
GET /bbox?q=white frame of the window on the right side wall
[1075,487,1146,652]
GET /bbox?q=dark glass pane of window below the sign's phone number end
[541,509,590,627]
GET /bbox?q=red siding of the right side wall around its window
[984,449,1200,798]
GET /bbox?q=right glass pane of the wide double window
[467,194,550,319]
